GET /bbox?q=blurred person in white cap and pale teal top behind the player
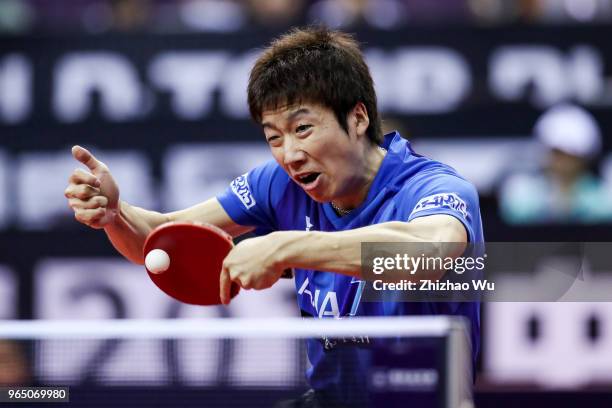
[500,104,612,224]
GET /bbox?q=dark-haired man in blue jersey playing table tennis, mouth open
[66,28,483,406]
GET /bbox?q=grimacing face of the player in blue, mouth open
[261,103,363,202]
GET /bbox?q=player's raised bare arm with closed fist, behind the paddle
[64,146,252,264]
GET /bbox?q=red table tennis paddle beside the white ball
[143,222,240,305]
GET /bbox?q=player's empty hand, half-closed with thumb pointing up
[64,146,119,228]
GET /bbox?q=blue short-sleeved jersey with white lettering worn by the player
[218,132,484,404]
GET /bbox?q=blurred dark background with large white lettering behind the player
[0,0,612,407]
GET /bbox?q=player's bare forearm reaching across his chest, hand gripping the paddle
[221,214,468,303]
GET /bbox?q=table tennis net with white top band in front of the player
[0,317,469,407]
